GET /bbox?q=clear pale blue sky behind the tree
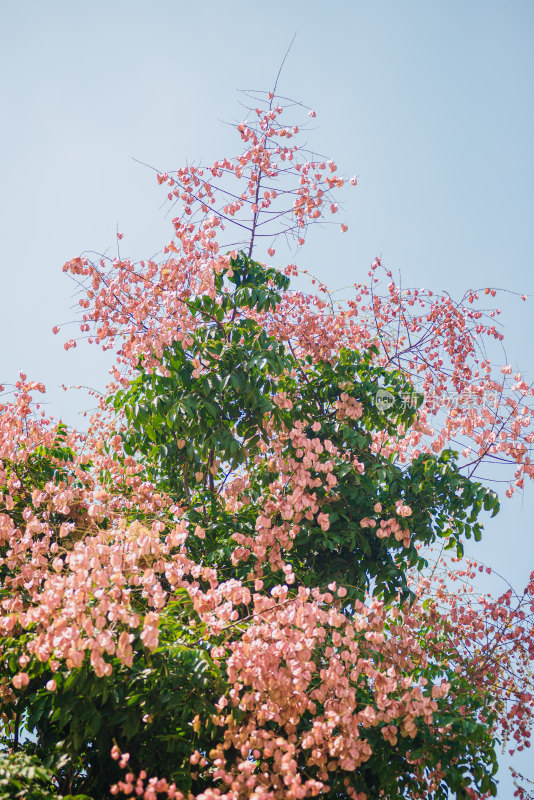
[0,0,534,800]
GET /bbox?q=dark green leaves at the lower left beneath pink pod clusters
[0,590,225,800]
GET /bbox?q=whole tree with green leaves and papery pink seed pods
[0,94,534,800]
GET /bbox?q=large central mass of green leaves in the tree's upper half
[112,253,498,600]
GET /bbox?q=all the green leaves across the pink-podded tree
[0,253,506,800]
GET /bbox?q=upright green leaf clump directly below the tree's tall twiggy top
[113,255,293,499]
